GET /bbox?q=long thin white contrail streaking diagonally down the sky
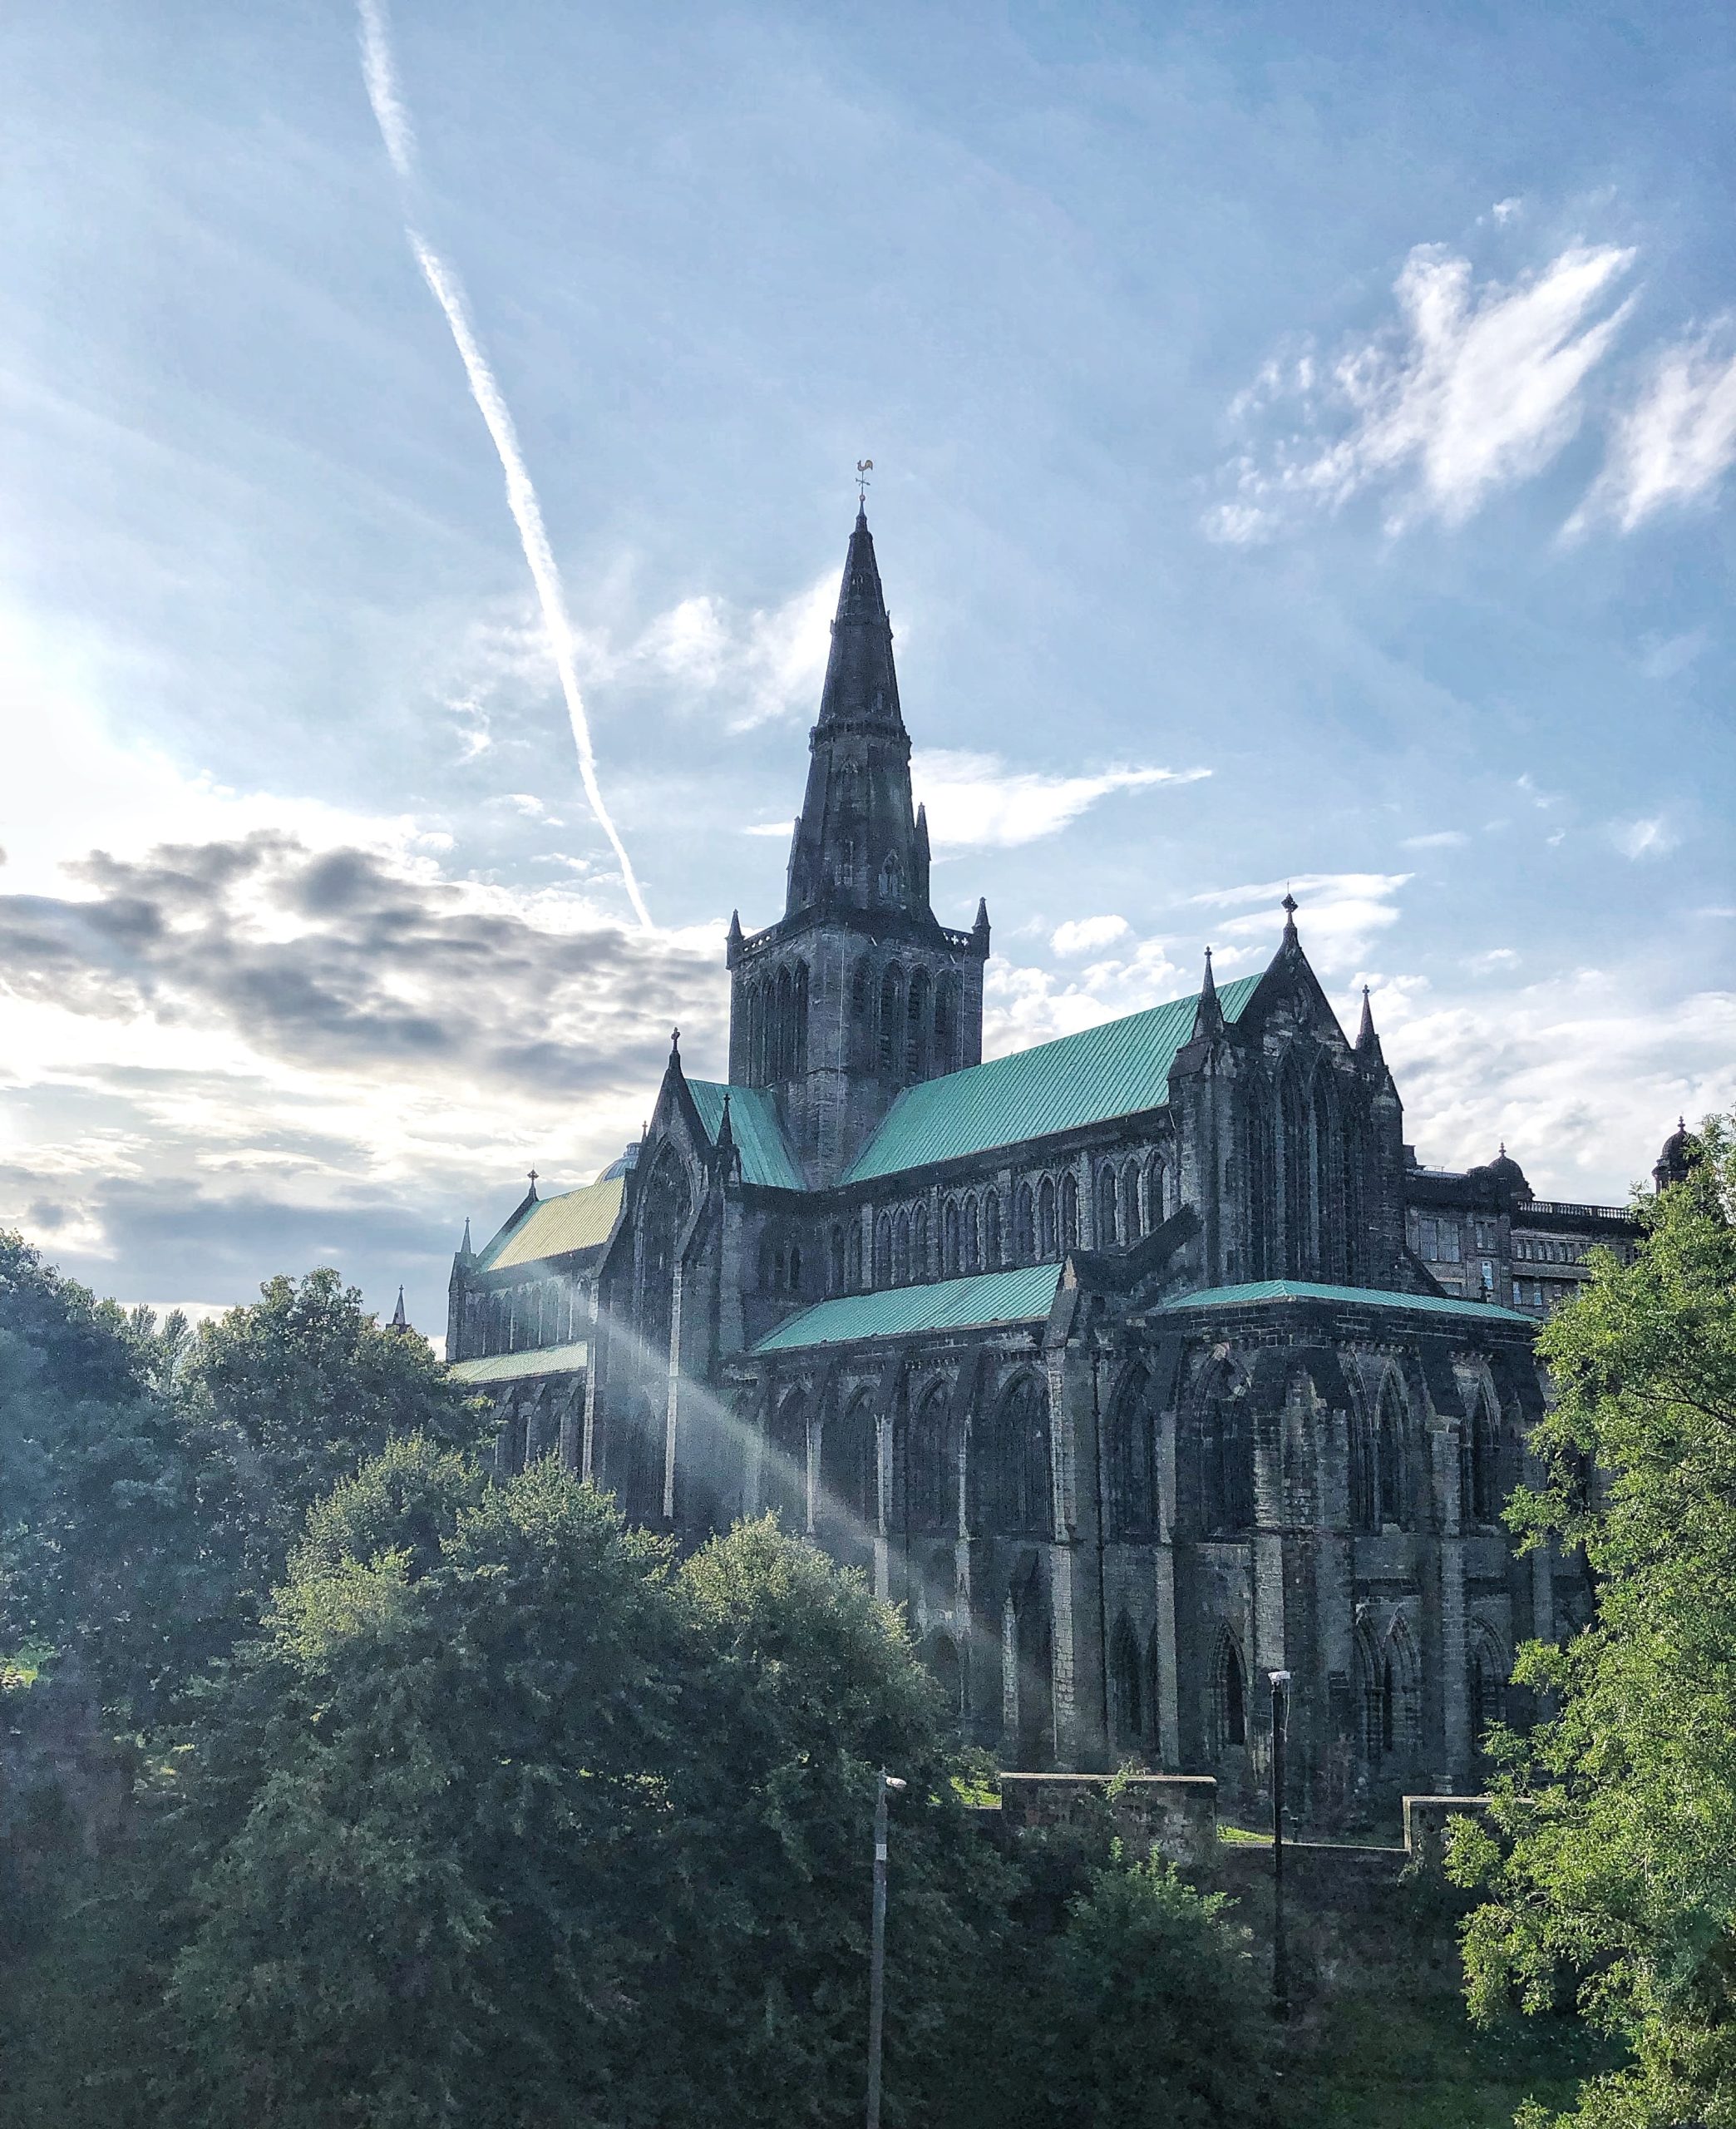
[358,0,651,931]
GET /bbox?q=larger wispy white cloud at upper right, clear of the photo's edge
[1206,245,1634,543]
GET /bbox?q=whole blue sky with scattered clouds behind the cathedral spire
[0,0,1736,1326]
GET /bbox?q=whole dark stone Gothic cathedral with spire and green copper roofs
[446,513,1650,1826]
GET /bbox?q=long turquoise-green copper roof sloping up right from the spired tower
[845,975,1260,1183]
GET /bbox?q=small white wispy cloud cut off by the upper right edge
[1566,319,1736,532]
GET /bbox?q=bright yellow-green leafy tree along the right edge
[1453,1120,1736,2129]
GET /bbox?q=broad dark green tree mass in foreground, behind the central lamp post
[15,1465,1002,2129]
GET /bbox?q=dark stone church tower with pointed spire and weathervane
[730,511,989,1186]
